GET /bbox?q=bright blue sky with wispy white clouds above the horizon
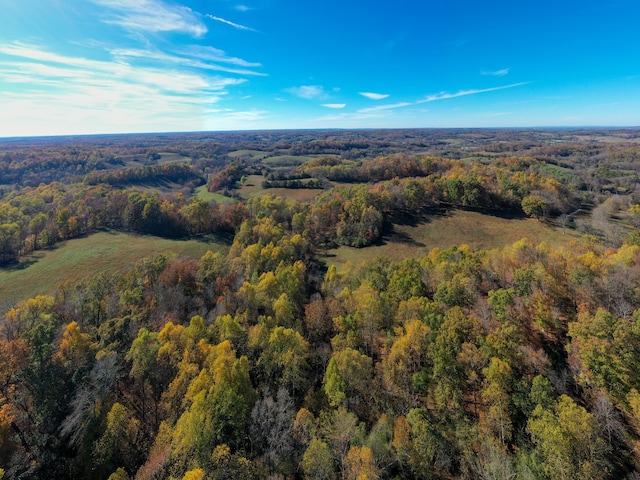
[0,0,640,136]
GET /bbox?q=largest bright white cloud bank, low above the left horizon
[0,43,252,136]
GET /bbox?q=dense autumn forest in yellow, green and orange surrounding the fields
[0,129,640,480]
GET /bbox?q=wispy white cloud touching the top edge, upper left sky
[90,0,207,37]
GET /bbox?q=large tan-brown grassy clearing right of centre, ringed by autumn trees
[323,210,579,270]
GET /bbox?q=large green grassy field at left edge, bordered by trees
[0,232,228,306]
